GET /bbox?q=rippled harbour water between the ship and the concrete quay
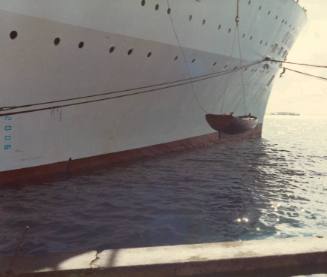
[0,116,327,254]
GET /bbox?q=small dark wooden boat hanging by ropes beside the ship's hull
[206,114,258,135]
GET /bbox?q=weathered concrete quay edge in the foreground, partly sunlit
[0,238,327,277]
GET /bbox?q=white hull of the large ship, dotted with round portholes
[0,0,306,183]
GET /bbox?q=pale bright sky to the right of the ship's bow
[267,0,327,115]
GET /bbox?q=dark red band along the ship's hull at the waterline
[0,125,262,185]
